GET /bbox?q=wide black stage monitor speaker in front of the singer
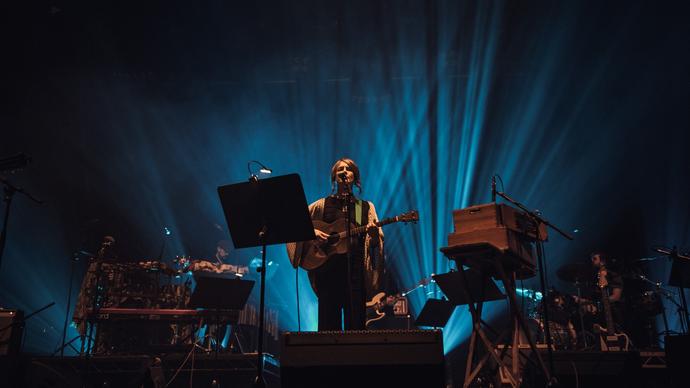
[280,330,445,388]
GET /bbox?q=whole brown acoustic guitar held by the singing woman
[292,210,419,271]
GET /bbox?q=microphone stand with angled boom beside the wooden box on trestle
[491,189,573,385]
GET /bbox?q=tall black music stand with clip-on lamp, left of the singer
[218,174,316,387]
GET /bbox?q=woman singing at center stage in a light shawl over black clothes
[288,158,384,331]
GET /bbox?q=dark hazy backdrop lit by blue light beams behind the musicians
[0,1,690,372]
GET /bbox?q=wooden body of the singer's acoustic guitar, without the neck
[300,218,355,271]
